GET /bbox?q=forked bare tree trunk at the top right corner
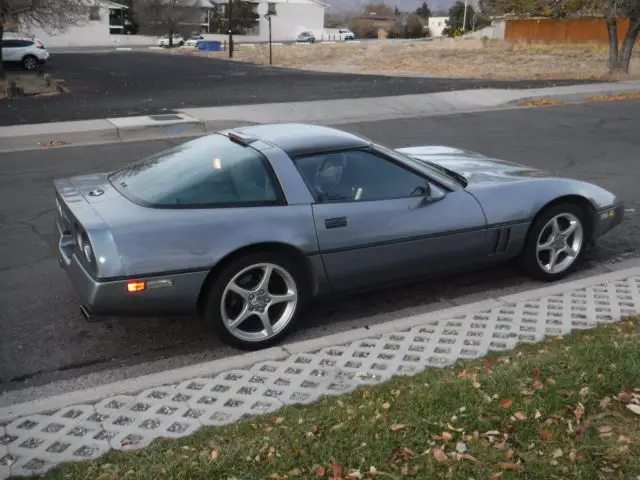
[604,0,640,74]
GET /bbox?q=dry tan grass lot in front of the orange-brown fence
[171,39,640,80]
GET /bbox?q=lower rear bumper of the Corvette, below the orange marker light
[59,244,207,317]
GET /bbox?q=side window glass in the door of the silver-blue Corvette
[295,150,427,203]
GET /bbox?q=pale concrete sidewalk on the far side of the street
[0,81,640,151]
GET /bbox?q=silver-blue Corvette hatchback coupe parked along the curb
[55,124,624,349]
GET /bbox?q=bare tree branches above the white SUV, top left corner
[0,0,91,78]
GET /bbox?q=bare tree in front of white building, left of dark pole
[135,0,205,47]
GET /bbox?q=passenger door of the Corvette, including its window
[296,150,488,291]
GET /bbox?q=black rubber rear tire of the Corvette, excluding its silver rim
[204,252,310,350]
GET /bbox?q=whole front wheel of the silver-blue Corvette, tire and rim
[519,203,589,281]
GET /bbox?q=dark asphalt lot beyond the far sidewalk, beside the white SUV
[0,50,600,125]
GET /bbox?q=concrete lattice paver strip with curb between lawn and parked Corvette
[0,267,640,478]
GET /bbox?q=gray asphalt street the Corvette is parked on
[0,102,640,392]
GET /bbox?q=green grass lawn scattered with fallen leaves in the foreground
[32,317,640,480]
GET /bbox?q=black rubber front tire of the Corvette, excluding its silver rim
[518,203,591,282]
